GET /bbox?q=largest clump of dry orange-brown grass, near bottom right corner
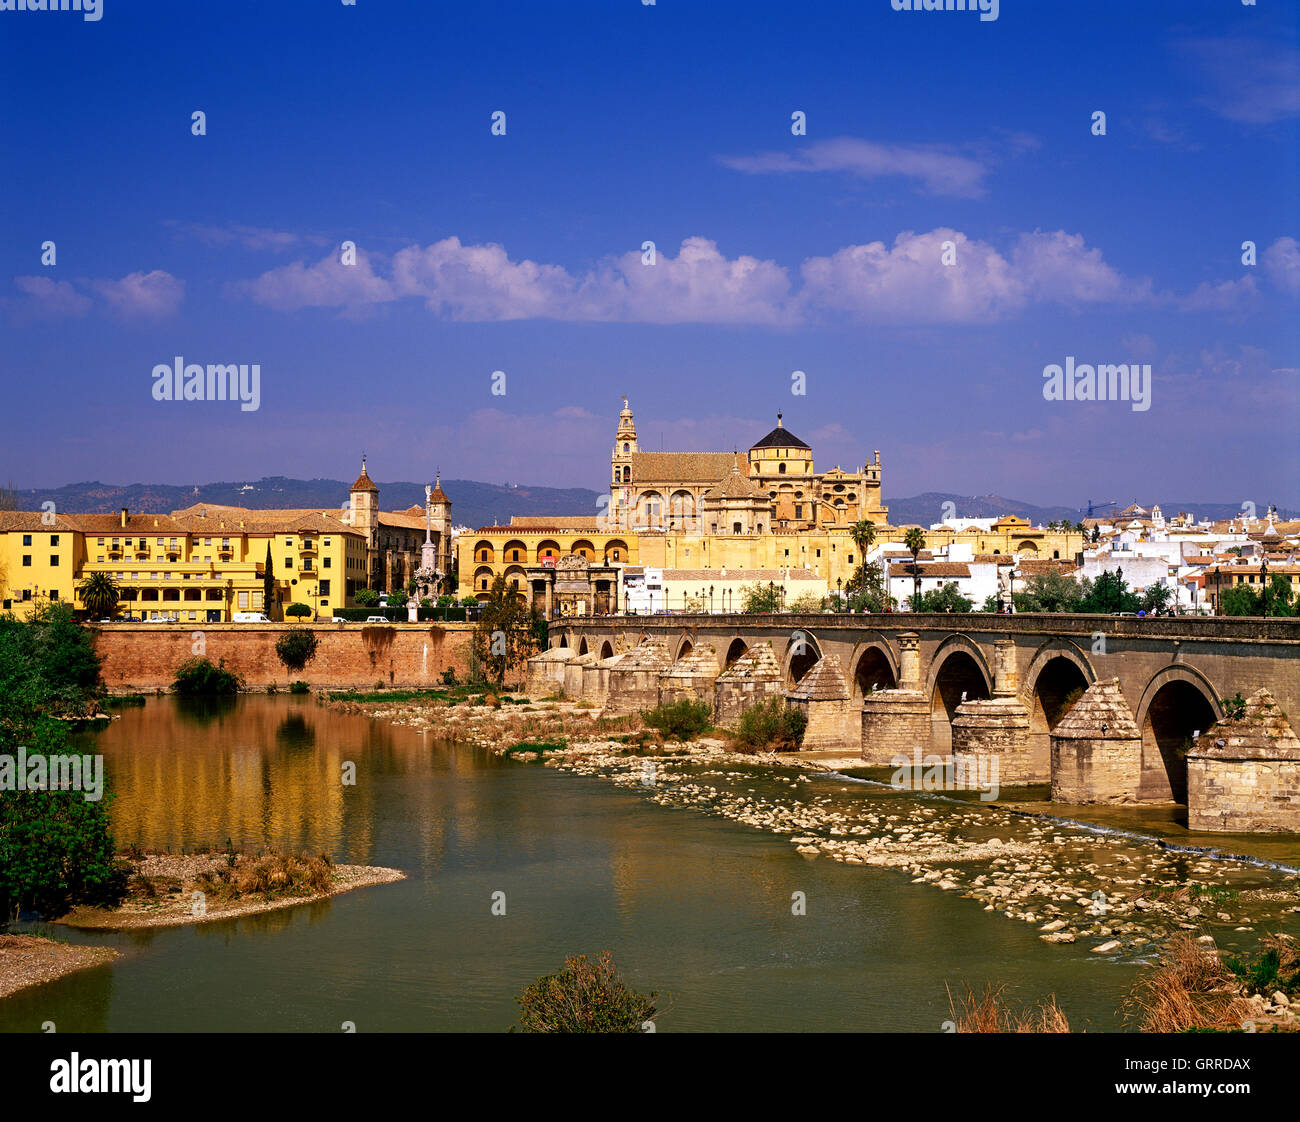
[1122,935,1255,1032]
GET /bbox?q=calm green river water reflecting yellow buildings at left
[0,697,1180,1032]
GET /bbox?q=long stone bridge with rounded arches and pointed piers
[542,614,1300,823]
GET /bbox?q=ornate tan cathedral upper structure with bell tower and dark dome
[608,398,889,534]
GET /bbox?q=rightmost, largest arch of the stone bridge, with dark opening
[1136,663,1223,802]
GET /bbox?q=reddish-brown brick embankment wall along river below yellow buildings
[95,623,473,693]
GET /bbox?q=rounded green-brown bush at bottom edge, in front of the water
[511,950,659,1032]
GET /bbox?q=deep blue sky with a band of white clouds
[0,0,1300,506]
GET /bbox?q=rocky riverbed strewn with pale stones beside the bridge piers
[332,699,1300,1018]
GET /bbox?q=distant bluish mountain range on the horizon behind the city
[7,476,1295,528]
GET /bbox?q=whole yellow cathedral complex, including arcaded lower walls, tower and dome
[458,408,1084,611]
